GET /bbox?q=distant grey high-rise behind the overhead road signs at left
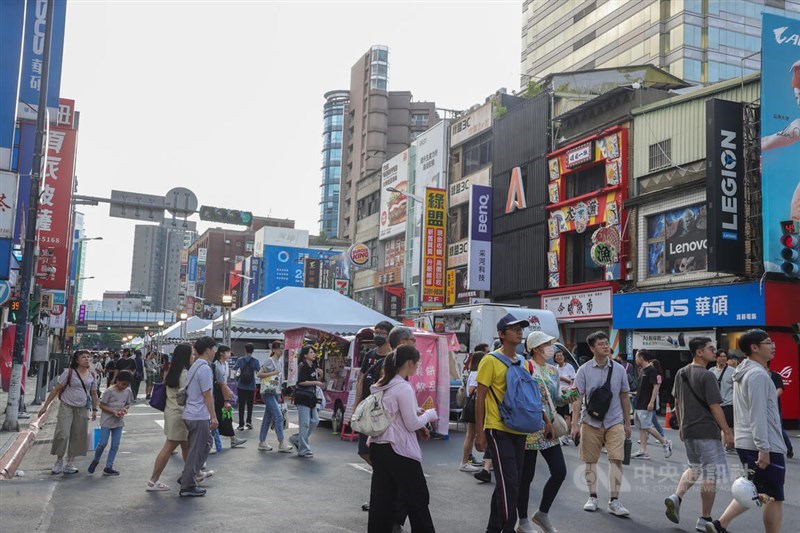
[131,220,197,310]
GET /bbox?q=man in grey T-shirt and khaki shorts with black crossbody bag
[572,331,631,516]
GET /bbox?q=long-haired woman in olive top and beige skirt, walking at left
[146,344,192,492]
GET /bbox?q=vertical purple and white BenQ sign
[467,185,492,291]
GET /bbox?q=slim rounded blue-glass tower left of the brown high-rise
[319,91,350,237]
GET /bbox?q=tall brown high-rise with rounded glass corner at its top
[339,45,439,241]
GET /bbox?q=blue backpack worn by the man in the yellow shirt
[489,352,544,433]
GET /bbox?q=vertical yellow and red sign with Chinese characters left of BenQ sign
[422,188,447,308]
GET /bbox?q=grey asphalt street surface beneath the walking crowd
[0,402,800,533]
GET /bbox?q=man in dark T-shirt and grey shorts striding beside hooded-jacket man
[664,337,733,531]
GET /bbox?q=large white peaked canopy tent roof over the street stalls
[212,287,398,336]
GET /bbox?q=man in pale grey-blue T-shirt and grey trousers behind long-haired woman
[180,337,219,496]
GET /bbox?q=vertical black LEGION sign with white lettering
[706,98,745,274]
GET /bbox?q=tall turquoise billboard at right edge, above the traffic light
[761,14,800,272]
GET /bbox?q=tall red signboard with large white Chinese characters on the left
[36,100,77,291]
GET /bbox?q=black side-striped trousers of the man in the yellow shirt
[486,429,525,533]
